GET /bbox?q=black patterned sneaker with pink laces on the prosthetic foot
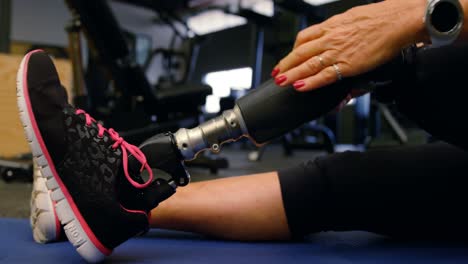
[17,50,154,262]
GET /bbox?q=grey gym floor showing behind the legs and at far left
[0,145,325,218]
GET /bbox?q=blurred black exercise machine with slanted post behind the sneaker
[66,0,211,136]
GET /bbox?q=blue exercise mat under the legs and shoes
[0,218,468,264]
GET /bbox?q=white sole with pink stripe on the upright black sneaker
[16,51,111,263]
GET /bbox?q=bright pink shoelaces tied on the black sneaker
[75,109,153,189]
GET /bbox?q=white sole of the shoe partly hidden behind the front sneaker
[29,161,61,244]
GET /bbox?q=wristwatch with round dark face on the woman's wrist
[424,0,464,47]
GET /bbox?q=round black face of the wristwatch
[430,1,462,33]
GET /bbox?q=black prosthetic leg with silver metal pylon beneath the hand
[140,43,468,207]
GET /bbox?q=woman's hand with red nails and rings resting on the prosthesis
[272,0,426,91]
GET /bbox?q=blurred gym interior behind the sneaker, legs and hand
[0,0,429,217]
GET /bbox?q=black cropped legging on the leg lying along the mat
[279,143,468,239]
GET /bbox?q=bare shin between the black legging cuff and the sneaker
[150,172,290,240]
